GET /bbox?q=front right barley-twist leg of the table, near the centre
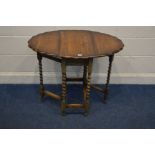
[84,59,93,115]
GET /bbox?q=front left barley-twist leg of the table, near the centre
[61,61,67,115]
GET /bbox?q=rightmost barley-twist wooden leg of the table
[104,55,114,101]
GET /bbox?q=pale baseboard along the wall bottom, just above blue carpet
[0,72,155,84]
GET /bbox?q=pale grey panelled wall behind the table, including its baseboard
[0,26,155,84]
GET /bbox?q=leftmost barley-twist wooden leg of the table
[37,54,44,99]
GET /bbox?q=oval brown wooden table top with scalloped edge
[28,30,124,59]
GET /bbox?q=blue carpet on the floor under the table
[0,85,155,129]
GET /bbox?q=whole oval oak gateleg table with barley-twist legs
[28,30,124,114]
